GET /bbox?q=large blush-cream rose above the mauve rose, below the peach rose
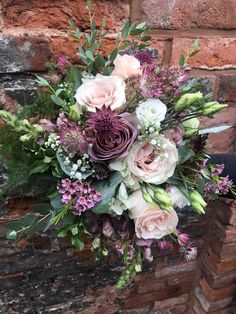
[75,74,126,112]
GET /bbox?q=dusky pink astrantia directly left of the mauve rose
[57,113,88,154]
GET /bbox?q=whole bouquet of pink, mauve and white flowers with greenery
[0,1,235,288]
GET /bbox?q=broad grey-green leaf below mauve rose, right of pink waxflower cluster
[92,171,122,214]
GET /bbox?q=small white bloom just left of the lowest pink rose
[110,183,134,215]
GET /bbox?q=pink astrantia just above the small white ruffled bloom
[139,64,162,98]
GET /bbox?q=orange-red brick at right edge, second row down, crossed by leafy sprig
[171,37,236,70]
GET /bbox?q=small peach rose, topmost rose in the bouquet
[112,54,142,79]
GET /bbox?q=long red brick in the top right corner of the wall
[142,0,236,29]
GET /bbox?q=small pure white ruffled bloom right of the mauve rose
[136,99,167,128]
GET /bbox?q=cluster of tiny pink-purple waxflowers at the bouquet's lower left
[57,179,102,215]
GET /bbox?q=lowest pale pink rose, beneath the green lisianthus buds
[130,190,178,239]
